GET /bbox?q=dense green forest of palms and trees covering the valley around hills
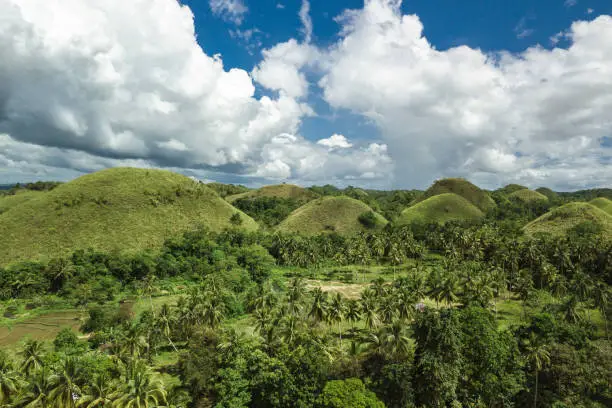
[0,171,612,408]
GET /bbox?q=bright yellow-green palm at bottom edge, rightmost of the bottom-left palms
[112,361,166,408]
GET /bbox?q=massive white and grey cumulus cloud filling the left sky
[0,0,392,185]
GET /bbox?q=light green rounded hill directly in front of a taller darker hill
[396,193,484,225]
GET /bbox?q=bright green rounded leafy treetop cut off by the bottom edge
[316,378,385,408]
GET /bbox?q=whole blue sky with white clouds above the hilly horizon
[0,0,612,190]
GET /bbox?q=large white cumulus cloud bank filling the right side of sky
[319,0,612,186]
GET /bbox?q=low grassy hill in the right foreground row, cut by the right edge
[524,202,612,236]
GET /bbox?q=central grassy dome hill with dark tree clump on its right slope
[277,196,388,235]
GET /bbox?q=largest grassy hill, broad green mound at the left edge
[0,168,257,264]
